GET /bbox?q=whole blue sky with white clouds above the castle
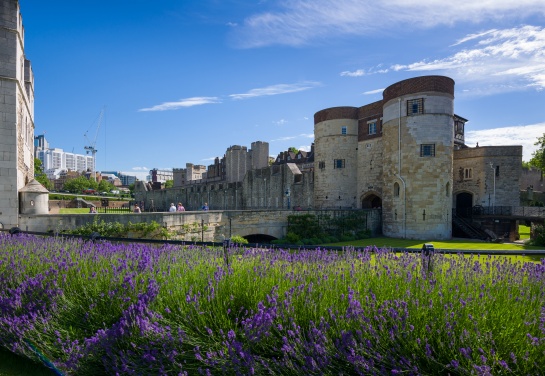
[20,0,545,177]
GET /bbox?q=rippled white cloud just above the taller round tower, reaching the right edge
[391,25,545,94]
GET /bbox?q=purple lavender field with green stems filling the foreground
[0,234,545,375]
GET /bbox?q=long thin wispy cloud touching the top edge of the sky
[231,0,545,48]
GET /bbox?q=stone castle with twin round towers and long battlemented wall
[136,76,522,239]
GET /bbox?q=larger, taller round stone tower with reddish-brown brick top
[382,76,454,239]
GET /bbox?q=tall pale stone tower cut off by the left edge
[0,0,34,228]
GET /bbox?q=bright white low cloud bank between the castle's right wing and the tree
[465,123,545,161]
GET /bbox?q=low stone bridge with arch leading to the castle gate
[19,209,382,242]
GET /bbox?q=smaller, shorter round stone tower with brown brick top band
[314,107,358,209]
